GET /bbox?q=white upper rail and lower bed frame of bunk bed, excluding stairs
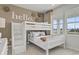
[24,21,65,55]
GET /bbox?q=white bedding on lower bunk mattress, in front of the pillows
[30,36,64,50]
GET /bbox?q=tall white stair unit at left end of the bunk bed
[12,23,26,55]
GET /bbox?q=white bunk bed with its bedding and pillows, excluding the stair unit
[24,21,65,55]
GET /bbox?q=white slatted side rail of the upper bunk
[24,21,52,31]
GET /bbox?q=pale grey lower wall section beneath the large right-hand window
[66,34,79,51]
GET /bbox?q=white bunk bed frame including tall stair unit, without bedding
[12,21,65,55]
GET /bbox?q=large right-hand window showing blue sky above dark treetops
[67,17,79,32]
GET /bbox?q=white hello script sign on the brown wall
[12,12,32,21]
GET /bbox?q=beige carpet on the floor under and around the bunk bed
[8,44,79,55]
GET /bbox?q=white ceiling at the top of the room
[15,4,60,13]
